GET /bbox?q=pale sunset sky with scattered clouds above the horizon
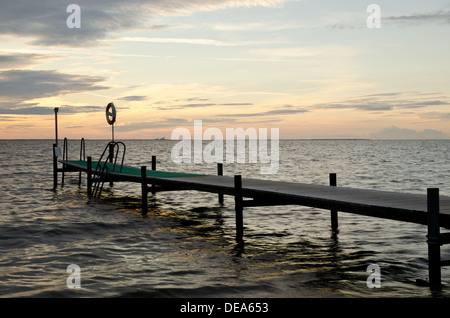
[0,0,450,139]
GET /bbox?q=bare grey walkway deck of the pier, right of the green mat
[166,176,450,228]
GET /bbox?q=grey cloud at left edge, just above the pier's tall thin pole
[0,70,108,114]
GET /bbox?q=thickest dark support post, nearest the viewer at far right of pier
[427,188,441,291]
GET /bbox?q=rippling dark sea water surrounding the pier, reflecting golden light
[0,140,450,297]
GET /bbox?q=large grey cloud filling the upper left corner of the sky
[0,0,296,48]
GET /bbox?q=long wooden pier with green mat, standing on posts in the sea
[53,145,450,291]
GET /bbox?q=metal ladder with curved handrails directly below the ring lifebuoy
[92,141,126,198]
